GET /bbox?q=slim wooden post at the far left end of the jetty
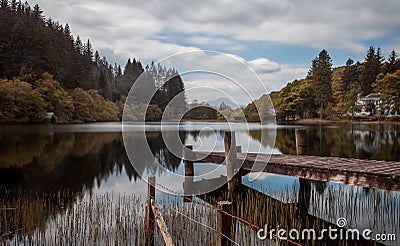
[183,145,194,202]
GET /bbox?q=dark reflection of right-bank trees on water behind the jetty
[249,124,400,161]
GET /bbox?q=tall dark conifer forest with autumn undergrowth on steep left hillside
[0,0,186,123]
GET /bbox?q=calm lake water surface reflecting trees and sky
[0,122,400,245]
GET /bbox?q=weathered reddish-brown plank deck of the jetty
[194,152,400,191]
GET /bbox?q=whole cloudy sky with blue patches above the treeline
[29,0,400,103]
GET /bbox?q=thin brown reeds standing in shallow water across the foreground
[0,185,400,245]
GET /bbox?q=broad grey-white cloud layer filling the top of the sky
[37,0,400,65]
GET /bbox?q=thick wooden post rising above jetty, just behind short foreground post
[224,131,242,191]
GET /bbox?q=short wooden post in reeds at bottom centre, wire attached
[217,201,234,246]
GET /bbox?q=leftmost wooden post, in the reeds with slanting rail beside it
[145,176,156,246]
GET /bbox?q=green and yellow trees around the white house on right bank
[262,47,400,120]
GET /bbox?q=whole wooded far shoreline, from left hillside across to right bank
[0,0,400,123]
